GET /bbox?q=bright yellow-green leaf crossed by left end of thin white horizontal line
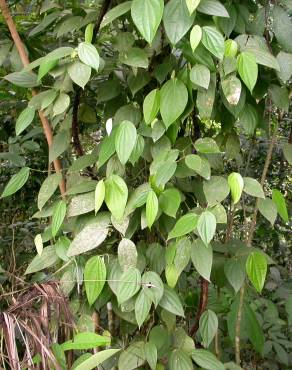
[84,256,106,306]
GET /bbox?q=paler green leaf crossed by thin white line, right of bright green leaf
[117,267,141,304]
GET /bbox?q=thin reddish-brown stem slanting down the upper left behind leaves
[0,0,66,196]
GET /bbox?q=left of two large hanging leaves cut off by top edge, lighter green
[131,0,164,44]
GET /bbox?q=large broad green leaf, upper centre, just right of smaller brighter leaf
[160,78,188,128]
